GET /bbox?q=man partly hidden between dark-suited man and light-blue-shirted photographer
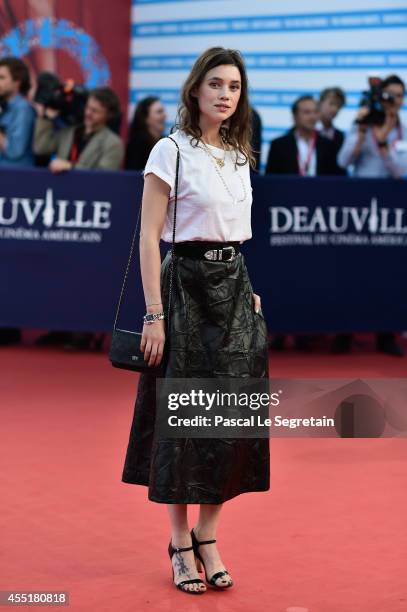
[316,87,347,176]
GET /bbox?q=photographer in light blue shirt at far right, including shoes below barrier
[332,74,407,357]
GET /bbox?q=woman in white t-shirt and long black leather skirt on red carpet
[122,47,270,594]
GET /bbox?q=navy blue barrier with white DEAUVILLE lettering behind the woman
[0,169,407,332]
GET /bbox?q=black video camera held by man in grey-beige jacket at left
[34,72,89,125]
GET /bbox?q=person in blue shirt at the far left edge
[0,57,35,167]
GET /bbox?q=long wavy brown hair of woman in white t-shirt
[171,47,256,168]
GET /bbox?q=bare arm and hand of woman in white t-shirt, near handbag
[140,173,170,366]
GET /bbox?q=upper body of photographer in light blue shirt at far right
[338,75,407,178]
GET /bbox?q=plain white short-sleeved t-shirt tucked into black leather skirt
[143,130,253,242]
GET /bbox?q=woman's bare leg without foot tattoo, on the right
[194,504,232,586]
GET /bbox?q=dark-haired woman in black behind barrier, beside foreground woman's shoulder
[125,96,166,170]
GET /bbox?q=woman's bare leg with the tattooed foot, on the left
[167,504,206,591]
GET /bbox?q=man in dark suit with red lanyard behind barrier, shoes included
[266,96,342,351]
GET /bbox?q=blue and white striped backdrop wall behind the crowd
[129,0,407,171]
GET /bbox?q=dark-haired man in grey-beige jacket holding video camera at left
[34,87,124,173]
